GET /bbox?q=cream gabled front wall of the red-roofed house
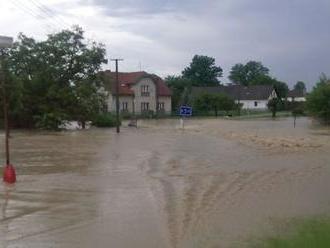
[132,78,157,113]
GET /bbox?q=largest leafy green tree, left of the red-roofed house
[8,27,106,128]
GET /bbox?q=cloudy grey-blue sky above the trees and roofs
[0,0,330,88]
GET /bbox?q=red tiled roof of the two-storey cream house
[101,71,172,96]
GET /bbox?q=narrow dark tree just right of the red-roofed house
[165,76,192,111]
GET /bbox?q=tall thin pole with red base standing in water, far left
[0,36,16,183]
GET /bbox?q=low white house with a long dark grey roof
[191,85,277,110]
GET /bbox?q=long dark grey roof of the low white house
[192,85,274,100]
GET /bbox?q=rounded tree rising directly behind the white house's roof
[228,61,269,86]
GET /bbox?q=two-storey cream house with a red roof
[100,70,172,114]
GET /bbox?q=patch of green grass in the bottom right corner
[250,218,330,248]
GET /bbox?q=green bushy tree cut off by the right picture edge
[307,74,330,123]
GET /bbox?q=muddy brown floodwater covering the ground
[0,118,330,248]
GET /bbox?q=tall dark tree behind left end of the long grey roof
[182,55,222,86]
